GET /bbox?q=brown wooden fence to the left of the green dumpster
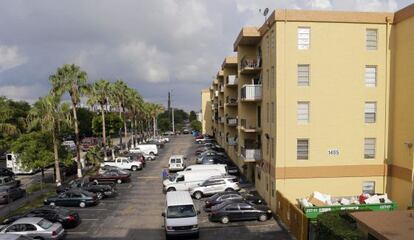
[276,191,309,240]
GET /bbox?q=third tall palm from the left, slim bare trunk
[88,79,111,157]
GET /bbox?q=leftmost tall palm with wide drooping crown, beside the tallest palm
[28,92,70,186]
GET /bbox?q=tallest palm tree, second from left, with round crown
[49,64,88,178]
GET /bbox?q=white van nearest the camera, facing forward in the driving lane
[162,191,200,239]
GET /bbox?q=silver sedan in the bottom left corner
[0,217,65,239]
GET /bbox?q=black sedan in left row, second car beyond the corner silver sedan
[44,189,99,208]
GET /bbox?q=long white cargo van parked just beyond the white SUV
[163,170,222,192]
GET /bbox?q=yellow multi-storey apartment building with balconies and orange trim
[202,5,414,209]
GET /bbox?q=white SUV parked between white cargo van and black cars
[190,175,240,199]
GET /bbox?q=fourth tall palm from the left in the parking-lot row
[111,79,129,145]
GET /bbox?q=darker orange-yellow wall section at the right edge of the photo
[389,13,414,209]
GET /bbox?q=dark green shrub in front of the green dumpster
[315,211,366,240]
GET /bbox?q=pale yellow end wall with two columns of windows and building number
[275,19,388,202]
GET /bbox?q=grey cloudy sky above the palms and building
[0,0,413,110]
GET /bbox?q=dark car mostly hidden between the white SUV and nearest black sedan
[204,191,264,212]
